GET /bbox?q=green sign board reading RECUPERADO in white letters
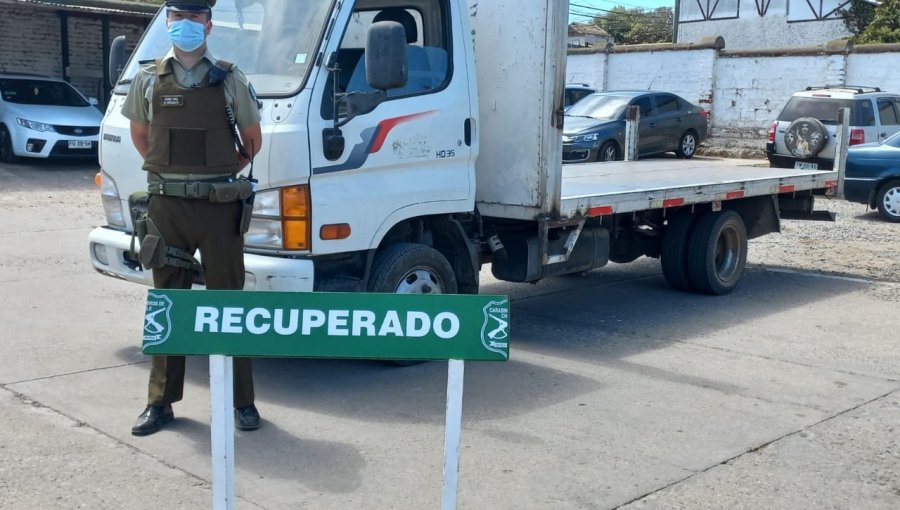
[143,289,509,361]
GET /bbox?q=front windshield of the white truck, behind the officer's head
[117,0,332,96]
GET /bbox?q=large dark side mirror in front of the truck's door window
[365,21,409,90]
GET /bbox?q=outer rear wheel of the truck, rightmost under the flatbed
[687,211,747,295]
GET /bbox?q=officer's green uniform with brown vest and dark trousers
[122,46,260,408]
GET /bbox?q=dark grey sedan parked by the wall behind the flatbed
[563,90,708,163]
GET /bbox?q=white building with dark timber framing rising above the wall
[678,0,850,50]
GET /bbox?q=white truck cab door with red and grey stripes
[309,0,476,253]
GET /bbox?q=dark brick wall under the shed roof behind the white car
[0,4,144,103]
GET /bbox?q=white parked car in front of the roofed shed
[0,74,103,162]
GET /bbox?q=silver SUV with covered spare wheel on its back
[766,85,900,170]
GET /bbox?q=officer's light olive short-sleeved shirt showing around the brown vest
[122,48,260,180]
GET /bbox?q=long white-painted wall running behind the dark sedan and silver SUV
[566,44,900,156]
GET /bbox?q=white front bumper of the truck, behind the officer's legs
[88,227,315,292]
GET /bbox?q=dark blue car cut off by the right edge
[844,133,900,223]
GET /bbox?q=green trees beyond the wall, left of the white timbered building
[593,5,674,44]
